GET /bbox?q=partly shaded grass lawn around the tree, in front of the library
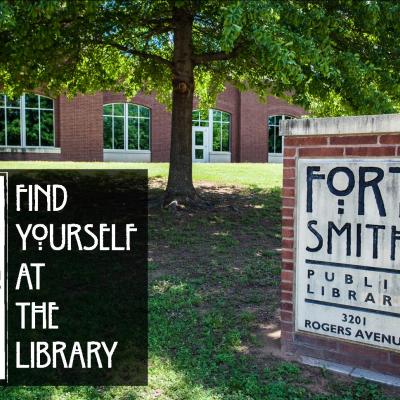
[0,163,398,400]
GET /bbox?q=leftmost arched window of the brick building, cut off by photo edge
[0,94,54,147]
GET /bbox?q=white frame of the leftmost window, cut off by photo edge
[0,93,56,149]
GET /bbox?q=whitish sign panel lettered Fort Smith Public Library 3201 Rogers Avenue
[295,158,400,351]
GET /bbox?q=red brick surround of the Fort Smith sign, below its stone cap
[281,134,400,375]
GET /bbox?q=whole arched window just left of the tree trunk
[103,103,150,150]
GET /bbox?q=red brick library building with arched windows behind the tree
[0,86,305,163]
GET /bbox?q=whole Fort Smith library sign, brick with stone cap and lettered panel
[281,115,400,376]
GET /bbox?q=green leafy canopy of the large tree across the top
[0,0,400,115]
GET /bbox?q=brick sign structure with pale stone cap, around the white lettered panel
[281,115,400,376]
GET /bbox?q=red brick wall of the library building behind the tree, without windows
[0,85,304,162]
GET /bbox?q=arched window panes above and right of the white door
[192,110,231,151]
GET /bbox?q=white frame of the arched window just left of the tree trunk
[102,103,152,153]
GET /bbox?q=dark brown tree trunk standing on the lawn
[164,8,197,205]
